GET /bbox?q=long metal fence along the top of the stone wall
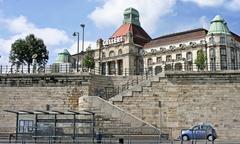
[0,62,240,76]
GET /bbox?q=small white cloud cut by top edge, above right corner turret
[181,0,225,7]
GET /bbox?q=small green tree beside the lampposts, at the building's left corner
[83,46,95,69]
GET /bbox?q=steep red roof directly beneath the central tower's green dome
[111,24,151,46]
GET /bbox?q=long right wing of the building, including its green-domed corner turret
[143,15,240,74]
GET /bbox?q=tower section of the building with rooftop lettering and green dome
[95,8,151,75]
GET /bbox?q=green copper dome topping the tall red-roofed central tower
[123,8,140,26]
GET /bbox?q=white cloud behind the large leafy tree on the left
[0,16,73,64]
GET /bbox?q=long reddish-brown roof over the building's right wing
[144,28,208,48]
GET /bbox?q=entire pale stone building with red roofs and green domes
[75,8,240,75]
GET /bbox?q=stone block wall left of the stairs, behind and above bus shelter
[0,86,88,132]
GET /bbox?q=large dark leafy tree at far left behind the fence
[9,34,48,73]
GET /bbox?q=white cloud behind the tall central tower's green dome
[89,0,176,33]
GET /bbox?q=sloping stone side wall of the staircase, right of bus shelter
[81,96,167,144]
